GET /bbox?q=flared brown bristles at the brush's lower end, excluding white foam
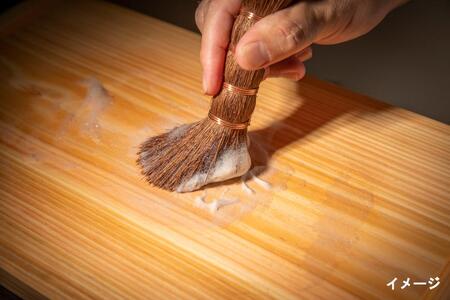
[137,119,247,192]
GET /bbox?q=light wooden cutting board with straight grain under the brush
[0,1,450,299]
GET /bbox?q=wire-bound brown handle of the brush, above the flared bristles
[210,0,290,123]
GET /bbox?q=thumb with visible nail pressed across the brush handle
[236,2,321,70]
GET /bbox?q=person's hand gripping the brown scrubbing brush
[195,0,407,95]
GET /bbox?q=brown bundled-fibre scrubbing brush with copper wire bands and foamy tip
[137,0,290,192]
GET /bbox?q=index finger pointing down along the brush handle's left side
[200,0,241,95]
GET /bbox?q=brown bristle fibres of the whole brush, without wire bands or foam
[137,0,289,191]
